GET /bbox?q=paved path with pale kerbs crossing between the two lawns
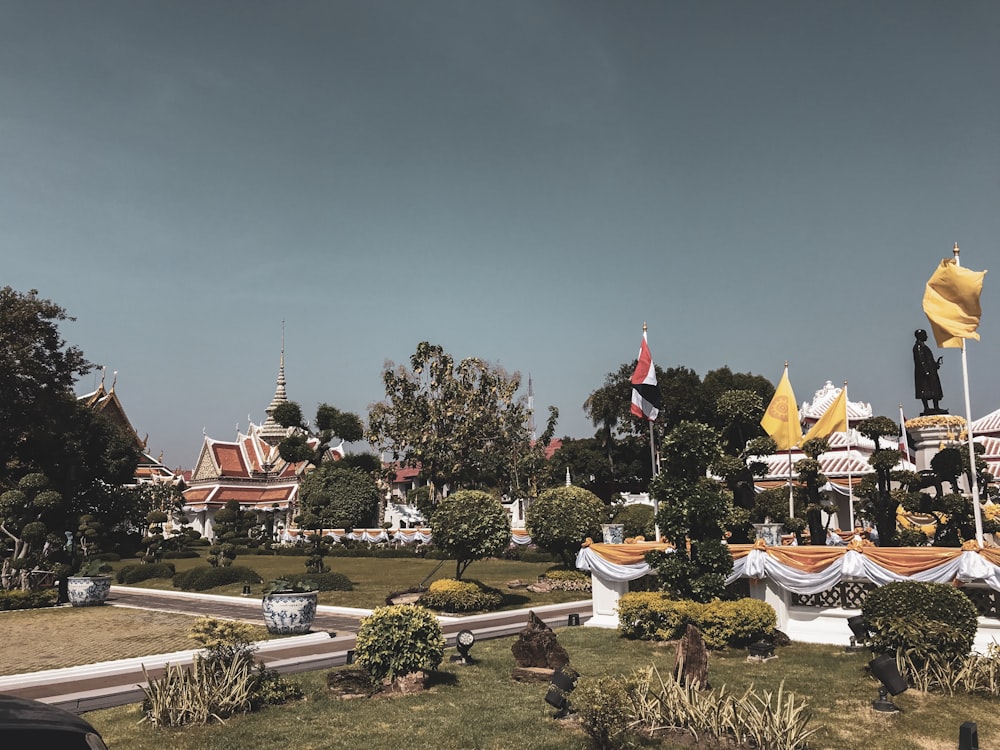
[0,586,593,713]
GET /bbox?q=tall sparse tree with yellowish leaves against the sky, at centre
[368,341,530,500]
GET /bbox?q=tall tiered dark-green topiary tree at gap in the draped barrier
[647,422,733,602]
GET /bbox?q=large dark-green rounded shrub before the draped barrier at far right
[861,581,978,660]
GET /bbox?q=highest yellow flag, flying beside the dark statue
[924,258,986,349]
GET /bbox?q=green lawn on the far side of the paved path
[114,555,590,609]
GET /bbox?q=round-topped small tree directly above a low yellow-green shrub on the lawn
[431,490,510,580]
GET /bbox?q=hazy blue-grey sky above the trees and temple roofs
[0,0,1000,468]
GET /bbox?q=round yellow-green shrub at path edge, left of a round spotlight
[354,604,445,682]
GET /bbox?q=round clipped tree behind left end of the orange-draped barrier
[527,486,606,566]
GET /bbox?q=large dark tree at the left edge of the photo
[0,287,146,580]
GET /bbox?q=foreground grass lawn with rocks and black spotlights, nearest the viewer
[87,627,1000,750]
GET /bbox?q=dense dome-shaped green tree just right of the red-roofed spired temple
[296,461,381,529]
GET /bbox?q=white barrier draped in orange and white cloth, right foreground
[576,540,1000,650]
